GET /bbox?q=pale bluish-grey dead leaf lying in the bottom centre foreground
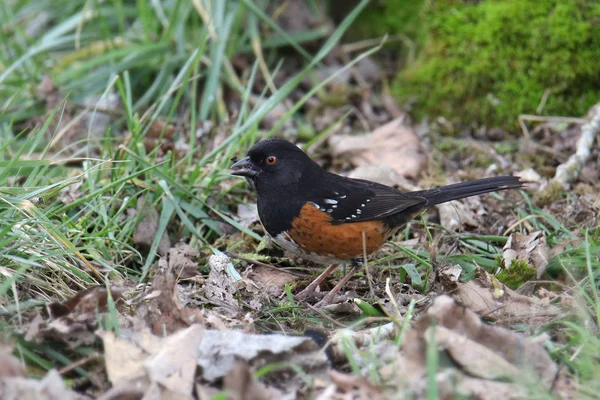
[198,330,327,382]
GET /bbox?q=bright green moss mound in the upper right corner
[394,0,600,131]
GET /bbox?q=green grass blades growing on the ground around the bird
[0,0,600,398]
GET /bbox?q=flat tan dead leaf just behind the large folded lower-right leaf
[437,265,564,326]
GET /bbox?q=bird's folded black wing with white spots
[311,174,427,224]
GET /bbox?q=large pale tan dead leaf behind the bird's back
[329,118,427,177]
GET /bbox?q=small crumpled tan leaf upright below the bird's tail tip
[502,231,549,279]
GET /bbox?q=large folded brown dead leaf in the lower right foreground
[380,296,569,399]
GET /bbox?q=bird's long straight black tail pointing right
[414,176,523,206]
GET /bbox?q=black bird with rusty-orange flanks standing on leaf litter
[230,138,524,306]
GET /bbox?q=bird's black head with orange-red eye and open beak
[231,138,321,192]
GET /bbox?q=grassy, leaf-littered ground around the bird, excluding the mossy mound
[0,0,600,399]
